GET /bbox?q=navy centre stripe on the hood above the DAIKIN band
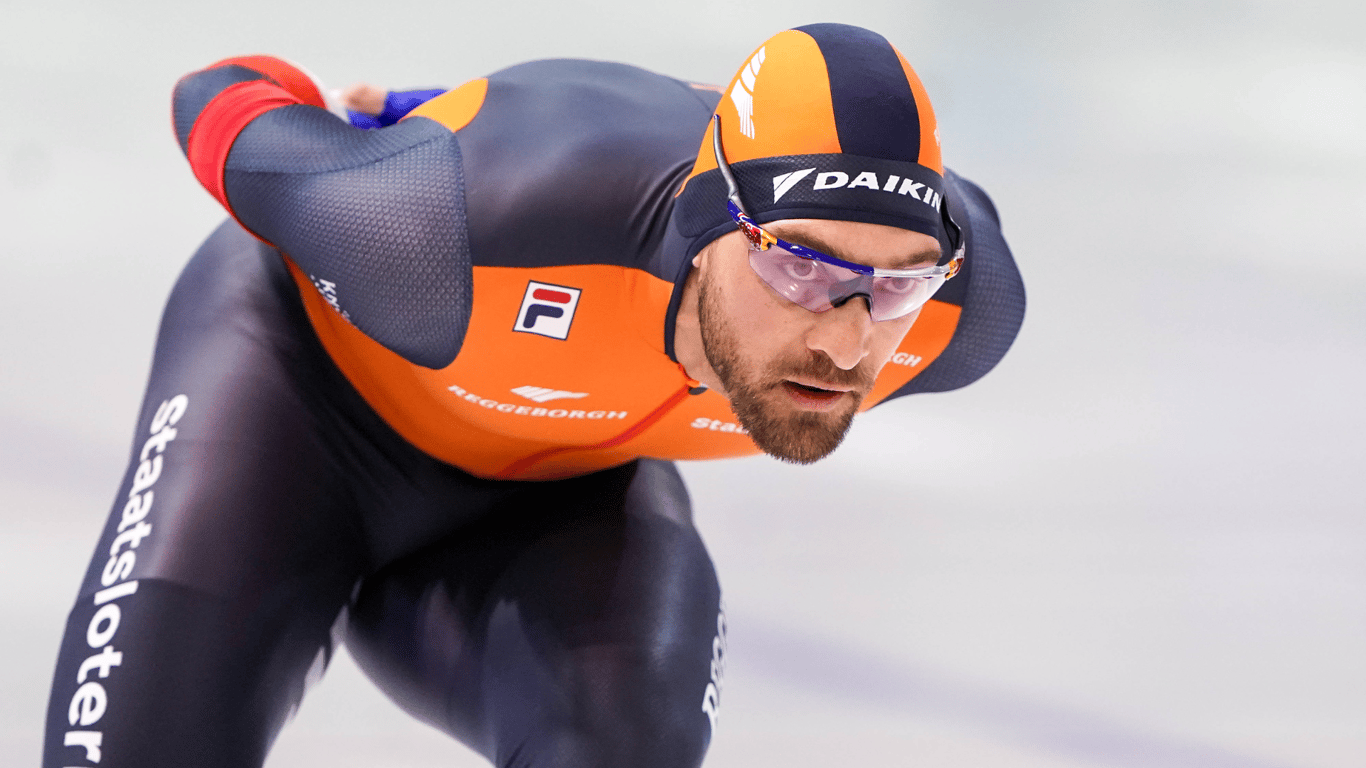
[796,25,921,163]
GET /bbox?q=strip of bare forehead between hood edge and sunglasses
[764,219,943,269]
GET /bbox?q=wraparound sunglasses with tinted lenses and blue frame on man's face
[712,115,964,323]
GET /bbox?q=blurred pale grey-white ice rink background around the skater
[0,0,1366,768]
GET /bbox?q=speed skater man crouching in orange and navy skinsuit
[44,25,1023,768]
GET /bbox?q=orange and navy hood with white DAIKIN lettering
[675,23,945,253]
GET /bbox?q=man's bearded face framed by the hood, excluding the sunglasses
[698,219,940,463]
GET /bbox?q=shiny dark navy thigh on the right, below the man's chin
[347,461,724,768]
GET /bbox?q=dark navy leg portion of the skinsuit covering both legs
[44,224,725,768]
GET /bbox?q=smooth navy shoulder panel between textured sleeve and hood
[456,60,719,266]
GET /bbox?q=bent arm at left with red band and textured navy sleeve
[172,56,473,368]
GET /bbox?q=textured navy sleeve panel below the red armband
[224,105,474,368]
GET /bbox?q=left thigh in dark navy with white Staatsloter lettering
[44,220,366,768]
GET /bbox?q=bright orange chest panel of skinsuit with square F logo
[290,262,958,480]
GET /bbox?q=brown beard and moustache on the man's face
[698,275,870,465]
